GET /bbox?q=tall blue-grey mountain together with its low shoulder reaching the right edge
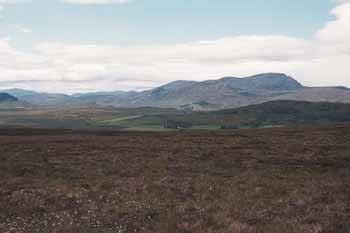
[97,73,350,111]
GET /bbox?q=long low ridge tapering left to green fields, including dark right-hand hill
[118,101,350,129]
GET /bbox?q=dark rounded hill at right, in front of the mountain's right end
[212,100,350,126]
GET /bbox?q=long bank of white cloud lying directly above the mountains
[0,4,350,92]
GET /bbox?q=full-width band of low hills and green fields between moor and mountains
[0,101,350,131]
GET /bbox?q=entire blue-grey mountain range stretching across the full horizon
[2,73,350,111]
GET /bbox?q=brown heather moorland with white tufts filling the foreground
[0,126,350,233]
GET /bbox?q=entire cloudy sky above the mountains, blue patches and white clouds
[0,0,350,93]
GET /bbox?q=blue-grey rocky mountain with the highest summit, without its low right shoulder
[119,73,303,109]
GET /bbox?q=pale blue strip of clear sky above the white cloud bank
[0,0,334,47]
